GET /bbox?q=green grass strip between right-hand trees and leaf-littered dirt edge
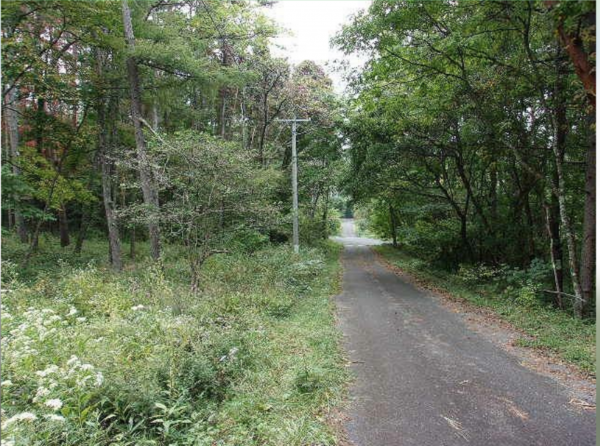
[375,245,596,376]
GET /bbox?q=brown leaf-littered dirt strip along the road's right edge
[375,247,596,410]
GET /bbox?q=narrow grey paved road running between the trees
[337,220,596,446]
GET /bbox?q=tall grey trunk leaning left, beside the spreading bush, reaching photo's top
[122,0,160,260]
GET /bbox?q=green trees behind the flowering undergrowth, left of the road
[2,1,341,278]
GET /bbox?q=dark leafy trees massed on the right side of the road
[336,1,596,317]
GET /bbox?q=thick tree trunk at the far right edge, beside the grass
[575,113,596,316]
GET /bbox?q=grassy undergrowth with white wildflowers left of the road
[2,237,347,445]
